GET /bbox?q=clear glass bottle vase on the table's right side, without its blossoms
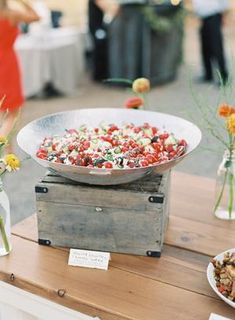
[214,150,235,220]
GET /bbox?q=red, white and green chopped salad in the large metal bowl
[36,123,187,169]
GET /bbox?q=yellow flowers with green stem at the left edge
[0,98,20,253]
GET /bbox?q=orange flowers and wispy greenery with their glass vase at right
[190,72,235,220]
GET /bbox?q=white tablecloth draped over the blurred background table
[15,28,85,97]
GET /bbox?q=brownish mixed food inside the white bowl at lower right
[212,252,235,302]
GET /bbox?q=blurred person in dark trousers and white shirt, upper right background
[192,0,229,84]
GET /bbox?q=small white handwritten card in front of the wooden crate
[68,249,110,270]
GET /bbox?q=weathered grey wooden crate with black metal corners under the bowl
[35,172,170,257]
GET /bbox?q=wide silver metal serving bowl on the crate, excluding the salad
[17,109,201,185]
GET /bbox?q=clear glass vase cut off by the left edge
[0,181,11,256]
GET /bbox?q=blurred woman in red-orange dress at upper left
[0,0,39,135]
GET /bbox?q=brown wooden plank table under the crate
[0,172,235,320]
